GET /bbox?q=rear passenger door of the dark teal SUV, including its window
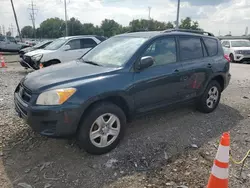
[179,36,218,100]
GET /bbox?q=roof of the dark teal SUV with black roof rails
[117,29,214,38]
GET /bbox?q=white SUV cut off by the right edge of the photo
[221,40,250,63]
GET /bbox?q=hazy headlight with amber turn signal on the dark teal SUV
[36,88,76,105]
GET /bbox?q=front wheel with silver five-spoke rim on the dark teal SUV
[77,102,126,155]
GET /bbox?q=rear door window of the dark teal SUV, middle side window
[179,37,203,61]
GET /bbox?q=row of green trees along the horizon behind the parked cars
[22,17,200,38]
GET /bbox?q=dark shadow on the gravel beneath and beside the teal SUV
[3,104,243,188]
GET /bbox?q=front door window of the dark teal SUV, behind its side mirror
[143,37,176,66]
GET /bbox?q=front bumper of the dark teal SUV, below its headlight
[14,93,81,137]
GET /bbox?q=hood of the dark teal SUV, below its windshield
[22,60,117,93]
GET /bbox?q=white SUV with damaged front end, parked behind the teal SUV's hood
[21,35,105,69]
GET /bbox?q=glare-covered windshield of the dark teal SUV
[82,37,147,67]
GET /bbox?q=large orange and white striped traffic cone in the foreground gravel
[207,132,230,188]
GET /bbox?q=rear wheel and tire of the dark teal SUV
[197,80,222,113]
